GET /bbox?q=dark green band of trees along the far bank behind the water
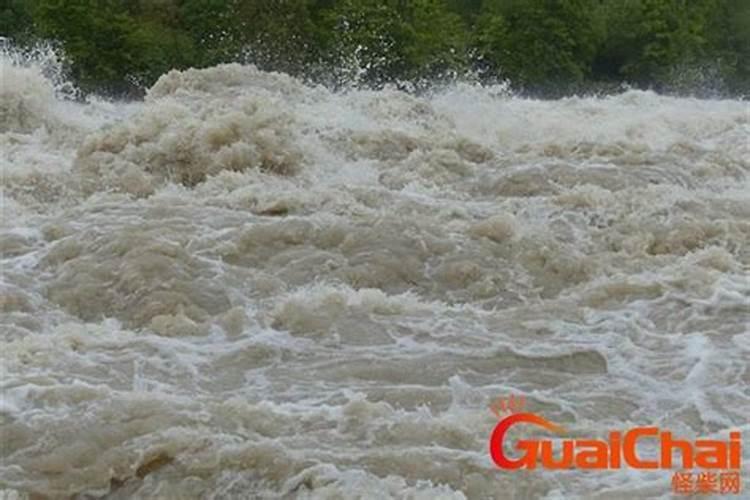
[0,0,750,96]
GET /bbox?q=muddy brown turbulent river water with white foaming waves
[0,48,750,500]
